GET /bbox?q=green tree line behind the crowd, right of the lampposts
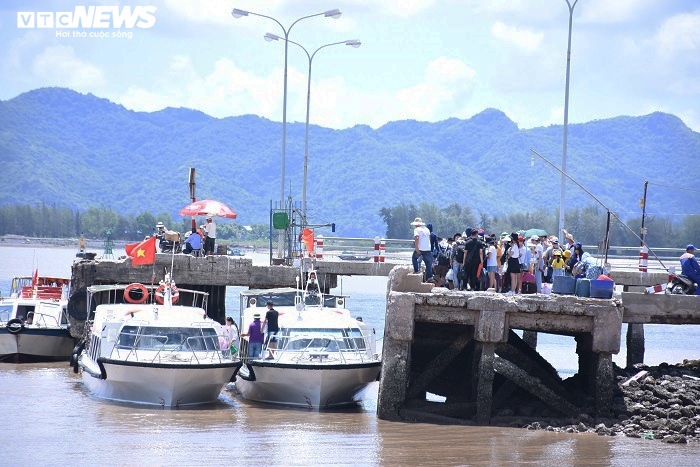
[379,203,700,248]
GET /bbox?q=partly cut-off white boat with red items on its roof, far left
[0,275,75,363]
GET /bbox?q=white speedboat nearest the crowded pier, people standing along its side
[236,272,381,409]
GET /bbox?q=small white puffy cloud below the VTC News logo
[32,45,104,91]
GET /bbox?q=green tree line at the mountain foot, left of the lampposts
[0,204,269,242]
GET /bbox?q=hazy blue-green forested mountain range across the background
[0,88,700,237]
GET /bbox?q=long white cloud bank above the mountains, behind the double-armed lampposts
[112,56,476,128]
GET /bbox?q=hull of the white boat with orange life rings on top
[80,358,241,407]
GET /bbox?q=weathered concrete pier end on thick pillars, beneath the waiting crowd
[377,267,656,425]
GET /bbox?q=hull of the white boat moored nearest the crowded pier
[236,361,381,409]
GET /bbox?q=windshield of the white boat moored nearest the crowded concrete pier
[278,328,366,352]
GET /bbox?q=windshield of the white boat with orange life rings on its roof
[117,326,220,350]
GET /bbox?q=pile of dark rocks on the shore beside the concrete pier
[510,360,700,443]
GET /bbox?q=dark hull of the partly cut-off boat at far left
[0,327,75,363]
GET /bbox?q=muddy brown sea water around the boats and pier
[0,246,700,466]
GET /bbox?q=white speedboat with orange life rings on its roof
[75,283,241,407]
